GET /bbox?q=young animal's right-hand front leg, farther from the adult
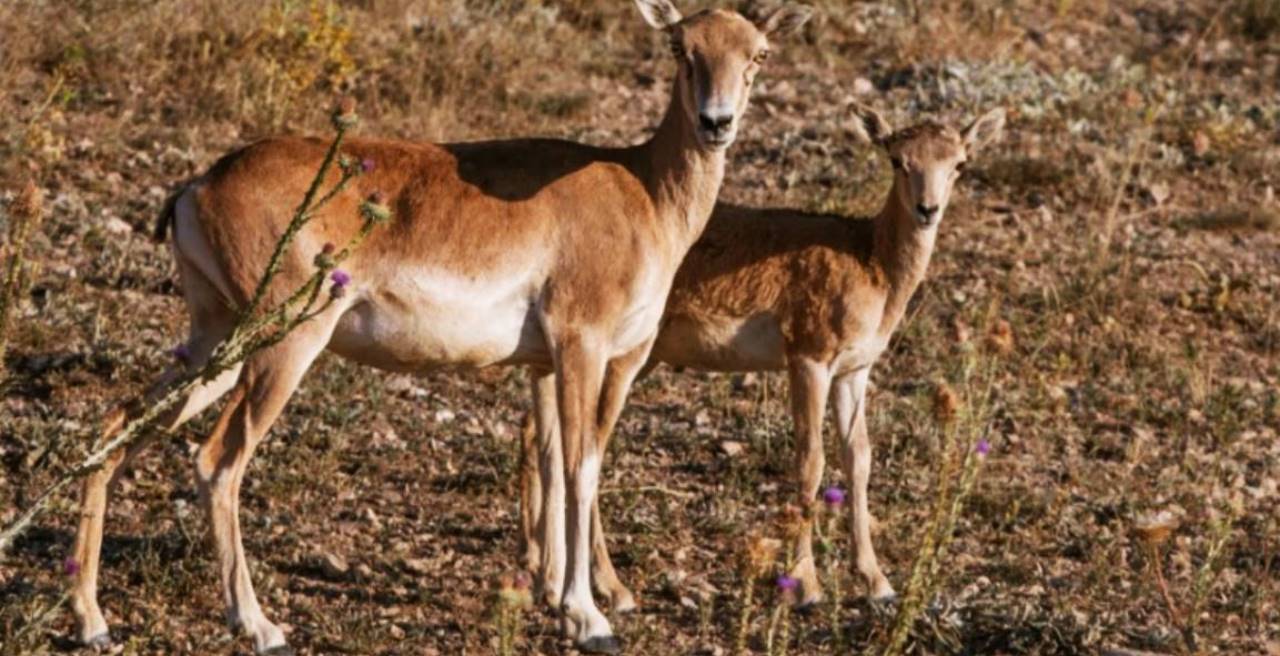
[832,368,893,600]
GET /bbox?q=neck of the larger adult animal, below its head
[636,74,724,248]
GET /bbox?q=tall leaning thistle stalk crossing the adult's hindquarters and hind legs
[0,97,392,555]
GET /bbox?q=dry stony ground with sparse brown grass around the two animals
[0,0,1280,655]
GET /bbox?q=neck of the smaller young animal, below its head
[872,185,941,334]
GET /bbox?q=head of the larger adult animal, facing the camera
[635,0,813,150]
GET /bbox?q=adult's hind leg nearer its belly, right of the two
[196,324,332,653]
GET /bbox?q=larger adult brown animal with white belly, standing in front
[73,0,809,653]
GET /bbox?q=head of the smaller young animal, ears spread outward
[850,103,1005,229]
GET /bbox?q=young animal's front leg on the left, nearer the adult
[788,357,831,606]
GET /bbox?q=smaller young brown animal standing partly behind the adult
[521,104,1005,610]
